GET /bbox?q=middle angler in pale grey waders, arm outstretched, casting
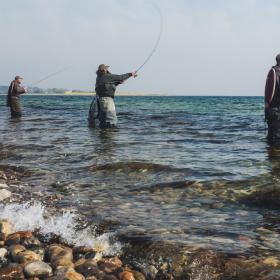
[88,64,137,128]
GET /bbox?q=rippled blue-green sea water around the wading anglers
[0,96,280,254]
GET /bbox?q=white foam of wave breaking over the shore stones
[0,202,122,256]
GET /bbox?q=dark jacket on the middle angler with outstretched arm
[95,72,132,98]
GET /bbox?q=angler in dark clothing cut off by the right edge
[265,54,280,145]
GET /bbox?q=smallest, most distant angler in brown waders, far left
[7,76,27,118]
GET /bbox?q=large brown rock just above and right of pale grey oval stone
[48,245,74,268]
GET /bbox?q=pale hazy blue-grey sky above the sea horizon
[0,0,280,95]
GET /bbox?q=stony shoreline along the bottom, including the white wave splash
[0,175,280,280]
